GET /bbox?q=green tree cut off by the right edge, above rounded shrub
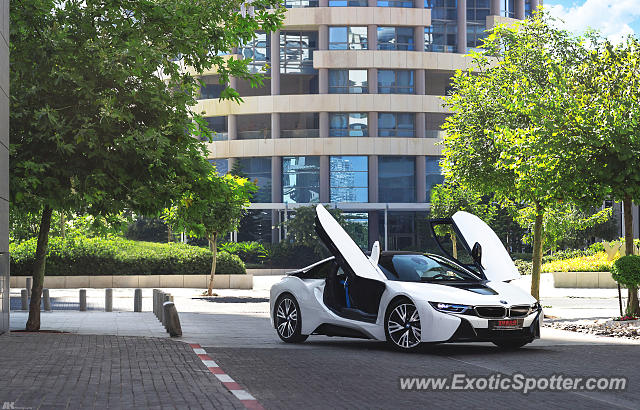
[574,37,640,315]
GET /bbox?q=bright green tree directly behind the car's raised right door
[443,13,603,298]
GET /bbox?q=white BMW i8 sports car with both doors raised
[270,205,543,351]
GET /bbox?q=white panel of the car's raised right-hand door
[451,211,520,281]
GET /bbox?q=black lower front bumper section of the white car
[447,310,542,342]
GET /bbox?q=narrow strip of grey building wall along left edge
[0,0,9,334]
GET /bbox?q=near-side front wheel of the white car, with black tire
[384,298,422,352]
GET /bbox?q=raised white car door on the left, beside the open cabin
[315,205,386,281]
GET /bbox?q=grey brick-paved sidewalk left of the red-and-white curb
[0,333,244,409]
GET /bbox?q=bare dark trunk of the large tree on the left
[26,205,52,332]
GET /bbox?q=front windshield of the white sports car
[379,254,480,282]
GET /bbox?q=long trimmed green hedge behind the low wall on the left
[9,237,246,276]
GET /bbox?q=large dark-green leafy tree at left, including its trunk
[9,0,282,330]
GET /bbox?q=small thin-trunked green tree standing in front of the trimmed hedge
[164,167,258,296]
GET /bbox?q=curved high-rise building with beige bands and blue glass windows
[196,0,539,249]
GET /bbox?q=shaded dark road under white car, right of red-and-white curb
[207,341,640,409]
